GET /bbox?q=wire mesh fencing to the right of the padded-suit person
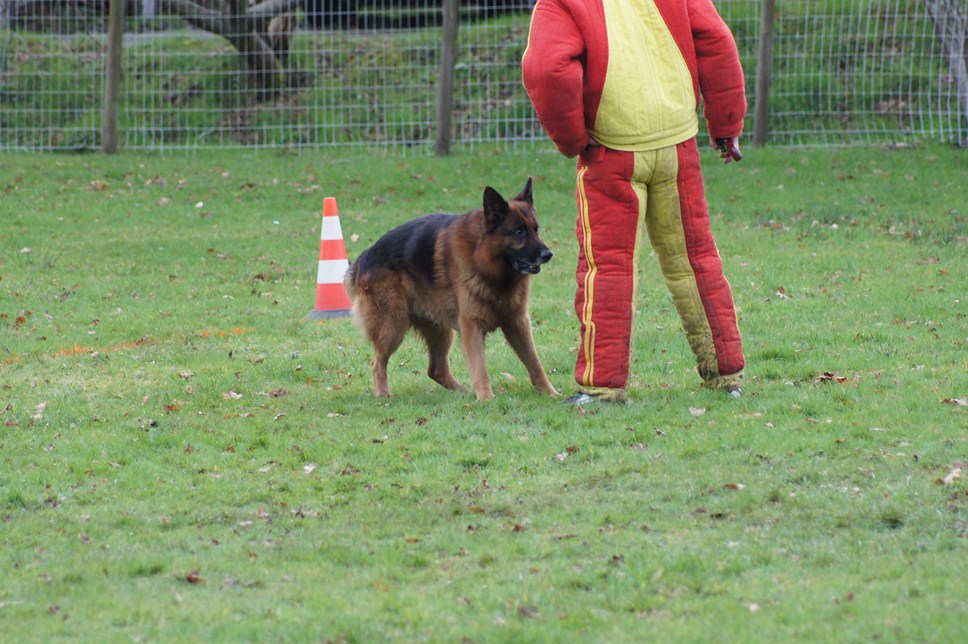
[732,0,968,145]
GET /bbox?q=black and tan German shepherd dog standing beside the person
[344,178,558,400]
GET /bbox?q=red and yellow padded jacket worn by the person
[522,0,746,157]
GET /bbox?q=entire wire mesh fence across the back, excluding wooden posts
[0,0,968,152]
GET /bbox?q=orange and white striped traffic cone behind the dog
[309,197,353,320]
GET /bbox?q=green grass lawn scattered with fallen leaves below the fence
[0,148,968,642]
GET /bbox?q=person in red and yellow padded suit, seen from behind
[522,0,747,405]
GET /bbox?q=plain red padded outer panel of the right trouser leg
[677,139,745,380]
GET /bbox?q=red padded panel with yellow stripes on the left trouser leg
[575,148,639,389]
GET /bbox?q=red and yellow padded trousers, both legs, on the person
[575,138,745,397]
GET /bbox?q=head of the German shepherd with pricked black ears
[484,177,552,275]
